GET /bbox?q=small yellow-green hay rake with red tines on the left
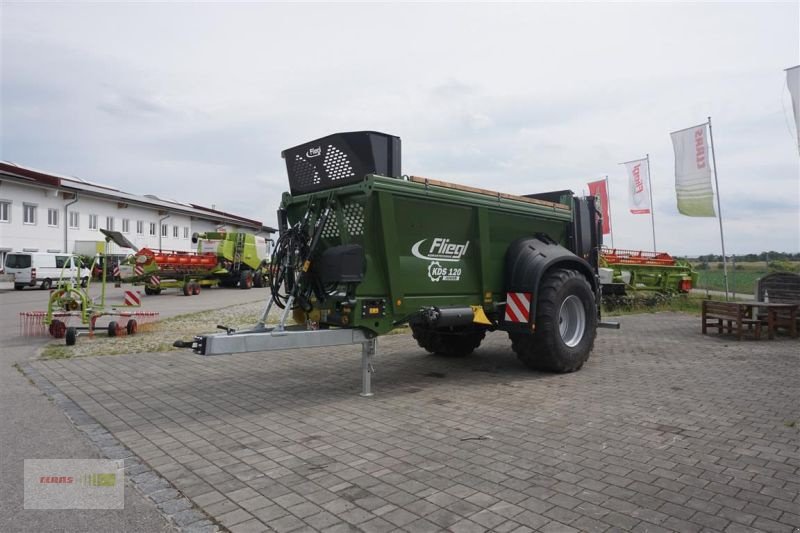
[19,229,159,346]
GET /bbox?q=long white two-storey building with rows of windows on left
[0,162,275,265]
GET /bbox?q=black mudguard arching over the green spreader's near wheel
[503,235,600,331]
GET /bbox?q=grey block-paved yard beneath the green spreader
[20,313,800,533]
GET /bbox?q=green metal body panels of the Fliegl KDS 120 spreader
[282,175,573,334]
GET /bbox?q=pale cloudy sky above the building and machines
[0,1,800,255]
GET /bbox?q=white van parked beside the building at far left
[5,252,92,291]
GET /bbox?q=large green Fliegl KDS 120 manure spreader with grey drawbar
[176,131,614,393]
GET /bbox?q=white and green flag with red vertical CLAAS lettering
[670,124,717,217]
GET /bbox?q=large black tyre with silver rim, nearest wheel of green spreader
[509,269,597,373]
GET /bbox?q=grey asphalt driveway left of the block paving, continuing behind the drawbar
[0,285,265,533]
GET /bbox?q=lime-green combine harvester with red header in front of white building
[128,232,269,296]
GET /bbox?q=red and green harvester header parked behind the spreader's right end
[600,248,697,296]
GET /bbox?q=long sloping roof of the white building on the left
[0,161,277,233]
